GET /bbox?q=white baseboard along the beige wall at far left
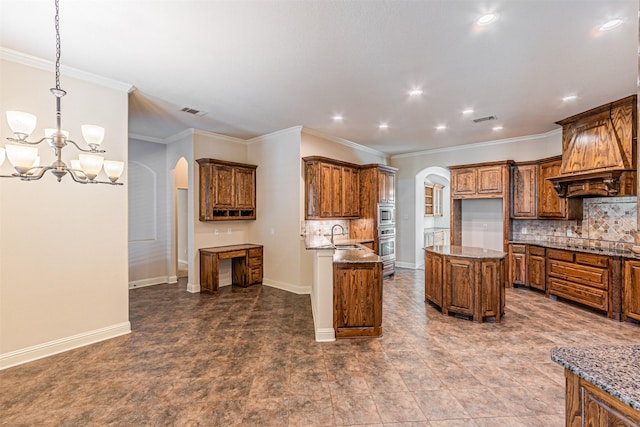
[0,322,131,370]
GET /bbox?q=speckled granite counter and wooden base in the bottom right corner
[551,345,640,427]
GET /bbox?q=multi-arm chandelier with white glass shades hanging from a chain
[0,0,124,185]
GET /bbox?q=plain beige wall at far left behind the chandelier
[0,56,130,368]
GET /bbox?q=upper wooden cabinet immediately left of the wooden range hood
[538,156,582,219]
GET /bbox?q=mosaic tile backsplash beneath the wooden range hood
[512,196,638,254]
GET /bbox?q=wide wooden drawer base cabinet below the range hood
[546,249,622,320]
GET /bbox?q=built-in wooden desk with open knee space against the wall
[200,243,262,294]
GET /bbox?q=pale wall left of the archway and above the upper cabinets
[390,130,562,267]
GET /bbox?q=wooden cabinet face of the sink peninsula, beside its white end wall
[333,262,382,338]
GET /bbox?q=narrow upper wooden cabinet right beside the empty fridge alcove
[511,163,538,219]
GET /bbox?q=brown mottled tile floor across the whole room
[0,269,640,427]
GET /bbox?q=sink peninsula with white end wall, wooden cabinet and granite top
[305,236,382,341]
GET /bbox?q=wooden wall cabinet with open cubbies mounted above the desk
[196,159,257,221]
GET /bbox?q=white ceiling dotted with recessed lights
[0,0,638,154]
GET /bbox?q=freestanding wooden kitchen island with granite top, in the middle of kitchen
[424,246,506,322]
